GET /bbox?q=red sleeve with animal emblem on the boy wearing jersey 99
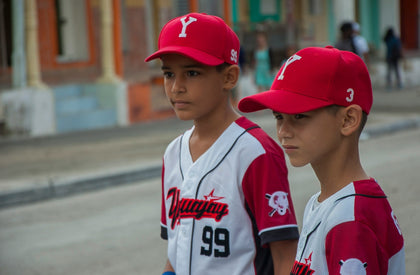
[242,153,299,245]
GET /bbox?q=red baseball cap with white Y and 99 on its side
[145,13,239,66]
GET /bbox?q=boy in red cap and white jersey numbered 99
[146,13,299,275]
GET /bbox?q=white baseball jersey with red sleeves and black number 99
[161,117,299,275]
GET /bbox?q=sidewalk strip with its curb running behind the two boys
[0,87,420,209]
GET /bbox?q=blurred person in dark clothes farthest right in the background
[384,27,403,89]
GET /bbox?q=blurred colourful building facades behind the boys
[0,0,420,136]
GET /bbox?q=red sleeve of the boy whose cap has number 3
[325,221,388,274]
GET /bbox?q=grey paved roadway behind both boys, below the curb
[0,129,420,275]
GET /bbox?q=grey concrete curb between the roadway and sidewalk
[0,116,420,209]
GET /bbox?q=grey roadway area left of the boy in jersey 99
[0,179,166,275]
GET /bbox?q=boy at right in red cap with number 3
[239,46,405,275]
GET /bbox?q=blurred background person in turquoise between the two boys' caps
[254,32,274,92]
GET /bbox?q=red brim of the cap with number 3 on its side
[238,90,333,114]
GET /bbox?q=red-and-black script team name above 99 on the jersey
[166,187,229,229]
